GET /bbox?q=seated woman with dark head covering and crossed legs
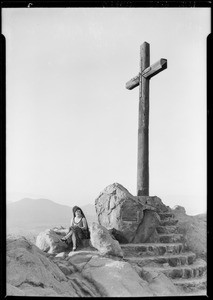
[61,206,90,251]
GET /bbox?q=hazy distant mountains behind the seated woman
[7,198,95,229]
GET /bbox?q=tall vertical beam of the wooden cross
[137,42,150,196]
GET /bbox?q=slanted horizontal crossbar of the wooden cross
[126,58,167,90]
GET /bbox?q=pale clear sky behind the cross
[2,8,210,215]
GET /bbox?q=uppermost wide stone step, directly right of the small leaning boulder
[120,243,184,257]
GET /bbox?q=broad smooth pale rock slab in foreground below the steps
[77,256,180,297]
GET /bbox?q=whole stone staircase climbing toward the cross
[121,212,206,295]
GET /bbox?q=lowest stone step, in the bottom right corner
[172,275,206,292]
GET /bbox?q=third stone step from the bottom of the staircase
[124,252,196,267]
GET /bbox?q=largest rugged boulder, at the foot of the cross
[95,183,168,243]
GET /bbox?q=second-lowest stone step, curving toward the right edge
[143,259,206,279]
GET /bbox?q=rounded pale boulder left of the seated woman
[36,229,70,254]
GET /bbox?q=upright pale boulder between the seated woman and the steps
[90,222,123,257]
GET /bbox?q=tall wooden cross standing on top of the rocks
[126,42,167,196]
